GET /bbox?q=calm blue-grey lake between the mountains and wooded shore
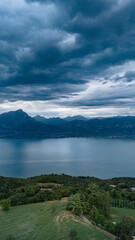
[0,138,135,178]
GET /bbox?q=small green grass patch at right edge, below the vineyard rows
[111,208,135,222]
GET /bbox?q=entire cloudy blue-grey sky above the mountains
[0,0,135,117]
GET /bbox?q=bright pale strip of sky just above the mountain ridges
[0,104,135,119]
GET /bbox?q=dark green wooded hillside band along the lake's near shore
[0,174,135,203]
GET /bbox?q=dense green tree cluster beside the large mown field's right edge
[67,183,110,223]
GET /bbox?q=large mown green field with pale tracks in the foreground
[0,201,111,240]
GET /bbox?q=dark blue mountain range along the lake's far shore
[0,109,135,139]
